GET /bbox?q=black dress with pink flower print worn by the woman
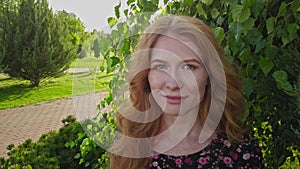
[148,135,264,169]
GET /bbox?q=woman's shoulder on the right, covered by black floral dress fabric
[214,135,264,168]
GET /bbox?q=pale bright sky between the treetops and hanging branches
[48,0,126,31]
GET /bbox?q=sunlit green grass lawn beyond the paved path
[0,58,112,110]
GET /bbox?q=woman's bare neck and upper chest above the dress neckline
[154,109,216,155]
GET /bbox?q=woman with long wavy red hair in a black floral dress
[110,16,263,169]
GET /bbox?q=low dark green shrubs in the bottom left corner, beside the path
[0,116,105,169]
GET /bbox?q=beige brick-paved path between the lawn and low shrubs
[0,93,105,158]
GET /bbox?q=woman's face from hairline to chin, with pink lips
[148,36,208,116]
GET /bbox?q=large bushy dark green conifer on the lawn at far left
[1,0,76,86]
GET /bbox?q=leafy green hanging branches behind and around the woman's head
[96,0,300,168]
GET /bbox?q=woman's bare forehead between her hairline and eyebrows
[151,35,201,61]
